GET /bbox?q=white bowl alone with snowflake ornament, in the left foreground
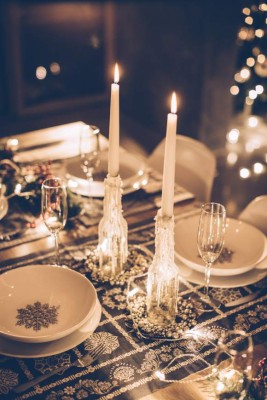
[0,265,97,343]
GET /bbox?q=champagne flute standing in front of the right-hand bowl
[197,203,226,311]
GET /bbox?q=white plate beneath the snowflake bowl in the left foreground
[0,299,101,358]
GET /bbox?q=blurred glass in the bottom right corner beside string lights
[213,330,253,400]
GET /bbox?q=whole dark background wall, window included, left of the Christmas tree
[0,0,243,152]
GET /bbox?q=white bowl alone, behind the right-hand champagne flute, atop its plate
[175,215,267,278]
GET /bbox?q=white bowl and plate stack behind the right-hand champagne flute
[175,215,267,288]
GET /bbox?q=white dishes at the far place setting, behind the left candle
[66,149,147,197]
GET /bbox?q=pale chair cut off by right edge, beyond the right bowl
[238,195,267,235]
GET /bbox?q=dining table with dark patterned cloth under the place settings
[0,122,267,400]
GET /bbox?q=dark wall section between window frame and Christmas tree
[115,0,242,151]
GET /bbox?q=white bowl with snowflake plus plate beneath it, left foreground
[0,265,101,358]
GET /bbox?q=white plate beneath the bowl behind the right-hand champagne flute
[175,255,267,289]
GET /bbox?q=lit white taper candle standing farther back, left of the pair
[108,63,120,177]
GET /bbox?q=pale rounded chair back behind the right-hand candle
[148,135,216,202]
